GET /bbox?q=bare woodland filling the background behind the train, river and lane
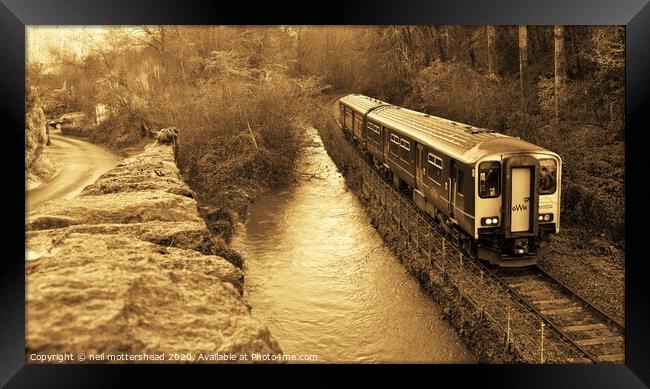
[26,26,625,247]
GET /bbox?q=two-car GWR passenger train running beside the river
[334,94,562,267]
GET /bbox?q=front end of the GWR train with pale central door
[468,138,562,266]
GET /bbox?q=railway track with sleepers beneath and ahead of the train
[330,113,625,363]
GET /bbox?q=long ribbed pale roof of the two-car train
[340,95,555,163]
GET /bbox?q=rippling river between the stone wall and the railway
[233,129,473,363]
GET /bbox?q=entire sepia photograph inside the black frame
[21,25,626,364]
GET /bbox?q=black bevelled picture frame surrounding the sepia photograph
[0,0,650,388]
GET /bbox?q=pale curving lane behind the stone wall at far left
[27,130,122,212]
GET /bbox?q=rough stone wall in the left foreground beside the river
[26,129,281,363]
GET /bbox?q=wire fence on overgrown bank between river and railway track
[355,156,590,363]
